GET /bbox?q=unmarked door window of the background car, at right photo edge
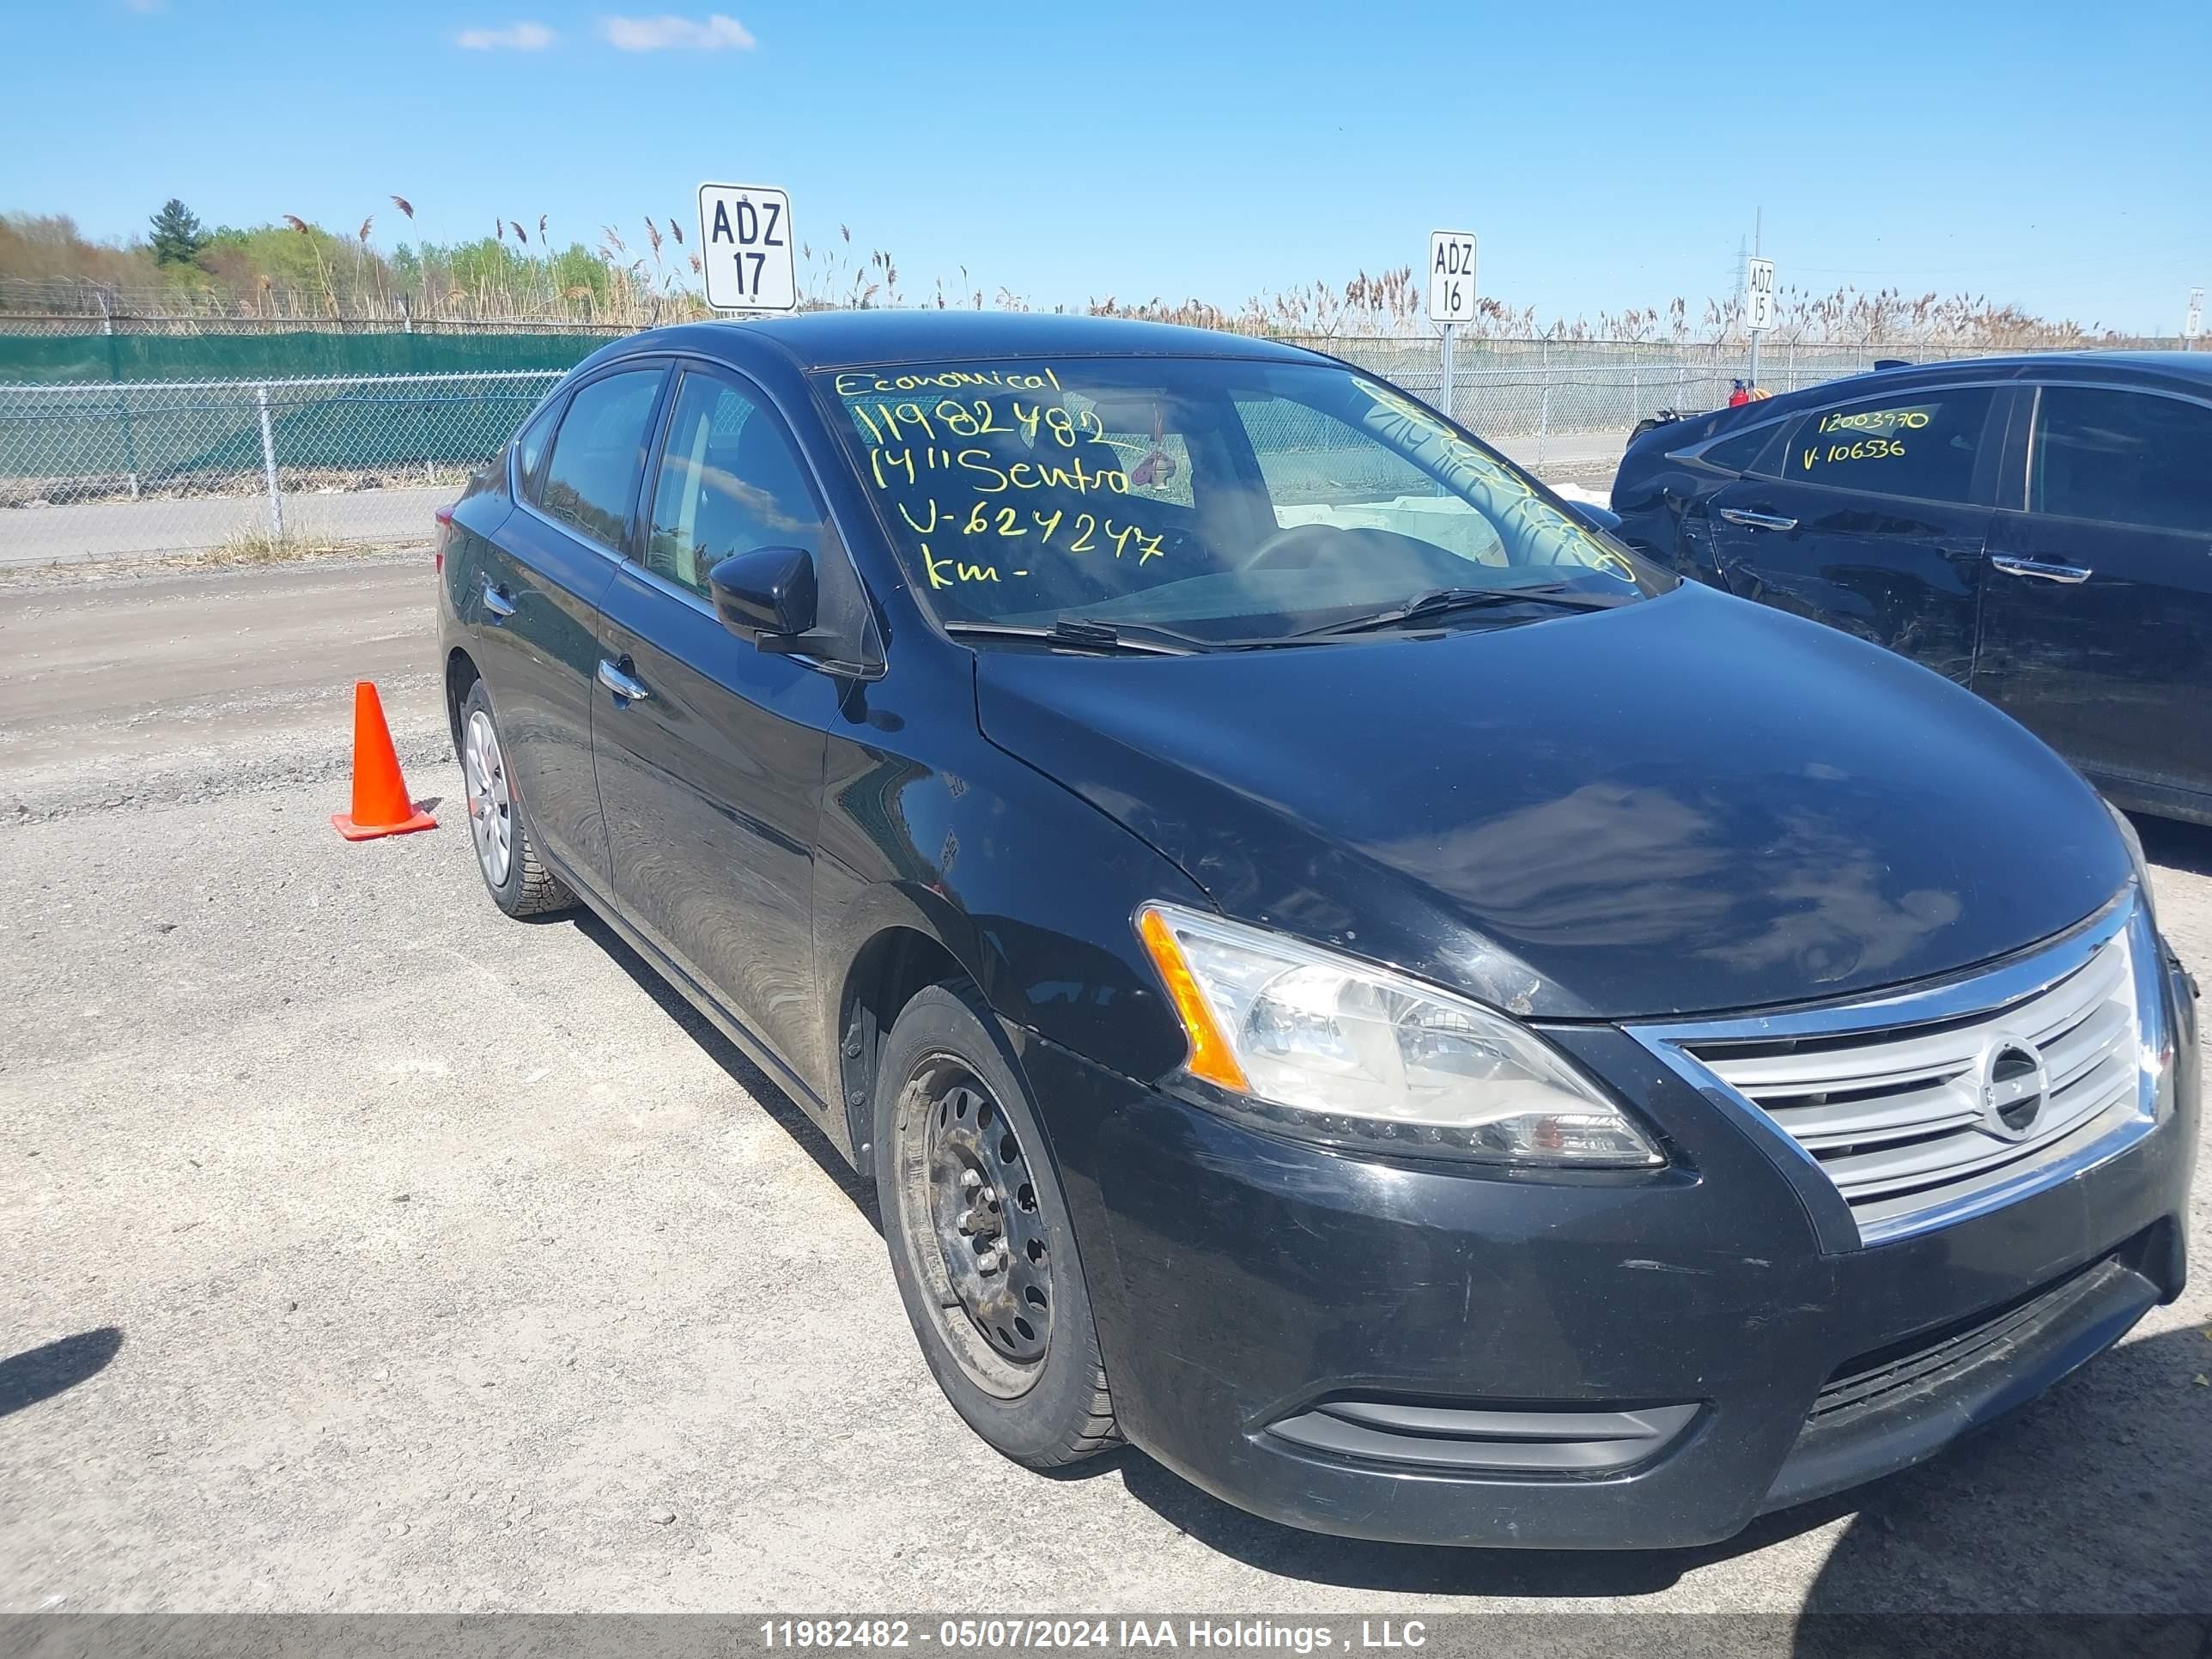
[2028,387,2212,535]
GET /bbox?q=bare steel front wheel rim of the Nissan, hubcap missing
[898,1055,1053,1398]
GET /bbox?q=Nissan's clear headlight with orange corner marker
[1137,905,1666,1170]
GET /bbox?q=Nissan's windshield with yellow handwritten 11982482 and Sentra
[817,356,1674,644]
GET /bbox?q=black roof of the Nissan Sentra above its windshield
[623,310,1322,369]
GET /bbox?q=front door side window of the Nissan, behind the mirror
[646,374,823,595]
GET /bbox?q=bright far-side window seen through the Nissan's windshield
[1237,398,1506,564]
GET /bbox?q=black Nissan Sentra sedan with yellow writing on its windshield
[441,314,2199,1547]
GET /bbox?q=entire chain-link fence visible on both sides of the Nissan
[0,337,2167,566]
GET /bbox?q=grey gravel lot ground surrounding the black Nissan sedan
[0,557,2212,1614]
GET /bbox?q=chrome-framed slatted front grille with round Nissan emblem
[1637,905,2150,1243]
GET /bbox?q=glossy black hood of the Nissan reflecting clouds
[975,584,2130,1020]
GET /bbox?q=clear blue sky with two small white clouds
[0,0,2212,331]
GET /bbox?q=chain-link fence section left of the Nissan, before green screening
[0,369,562,564]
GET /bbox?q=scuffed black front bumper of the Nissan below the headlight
[1024,967,2201,1548]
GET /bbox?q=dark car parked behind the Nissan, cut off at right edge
[1613,352,2212,823]
